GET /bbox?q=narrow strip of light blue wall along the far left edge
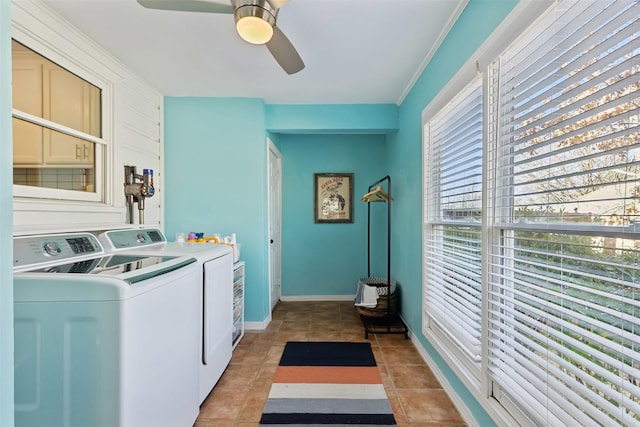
[0,0,13,426]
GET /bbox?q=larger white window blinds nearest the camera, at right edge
[486,1,640,426]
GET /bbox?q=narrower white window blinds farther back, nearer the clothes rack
[423,78,482,376]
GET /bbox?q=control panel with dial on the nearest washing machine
[13,233,104,269]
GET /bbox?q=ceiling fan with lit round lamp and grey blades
[137,0,304,74]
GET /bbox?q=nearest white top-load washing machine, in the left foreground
[14,233,200,427]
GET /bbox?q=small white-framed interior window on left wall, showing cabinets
[12,40,104,200]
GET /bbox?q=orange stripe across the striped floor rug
[273,366,382,384]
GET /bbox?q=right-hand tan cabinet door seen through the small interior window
[43,64,94,166]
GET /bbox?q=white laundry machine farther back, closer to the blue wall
[98,229,233,403]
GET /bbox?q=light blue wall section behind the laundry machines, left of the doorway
[160,97,270,322]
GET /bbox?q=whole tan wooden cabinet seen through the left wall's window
[13,47,100,168]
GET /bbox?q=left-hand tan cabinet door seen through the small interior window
[12,58,43,165]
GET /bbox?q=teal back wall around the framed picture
[274,135,388,296]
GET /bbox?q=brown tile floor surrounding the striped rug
[195,301,465,427]
